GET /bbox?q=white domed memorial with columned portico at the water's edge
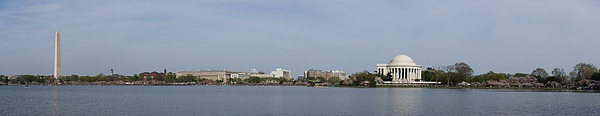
[377,55,424,84]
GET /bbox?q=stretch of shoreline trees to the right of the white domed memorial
[422,62,600,89]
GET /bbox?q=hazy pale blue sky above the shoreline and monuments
[0,0,600,77]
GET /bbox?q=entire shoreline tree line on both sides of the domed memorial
[0,62,600,89]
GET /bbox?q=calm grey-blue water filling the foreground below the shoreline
[0,86,600,116]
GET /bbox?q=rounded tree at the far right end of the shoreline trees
[569,63,598,81]
